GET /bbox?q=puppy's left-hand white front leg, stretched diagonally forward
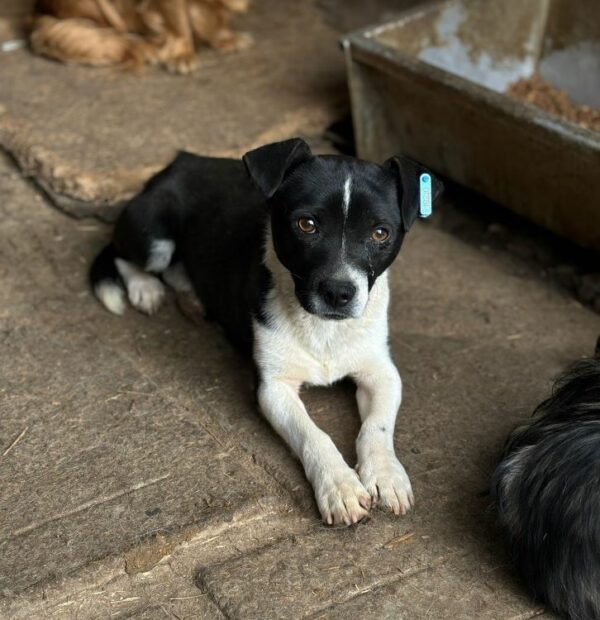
[258,380,371,525]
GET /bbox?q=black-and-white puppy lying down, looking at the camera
[90,139,441,524]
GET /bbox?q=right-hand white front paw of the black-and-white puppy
[357,452,415,515]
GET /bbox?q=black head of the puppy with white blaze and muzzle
[243,138,442,319]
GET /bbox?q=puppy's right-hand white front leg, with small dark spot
[353,359,414,514]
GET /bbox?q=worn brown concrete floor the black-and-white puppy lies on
[0,3,600,620]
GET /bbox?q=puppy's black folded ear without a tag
[242,138,313,198]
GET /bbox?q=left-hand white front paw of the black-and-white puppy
[314,464,371,525]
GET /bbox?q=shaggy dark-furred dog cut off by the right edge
[492,342,600,620]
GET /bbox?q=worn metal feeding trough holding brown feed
[342,0,600,250]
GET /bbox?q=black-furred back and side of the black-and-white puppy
[113,152,269,352]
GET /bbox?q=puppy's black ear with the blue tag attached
[383,155,444,232]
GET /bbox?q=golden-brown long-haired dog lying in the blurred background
[29,0,251,73]
